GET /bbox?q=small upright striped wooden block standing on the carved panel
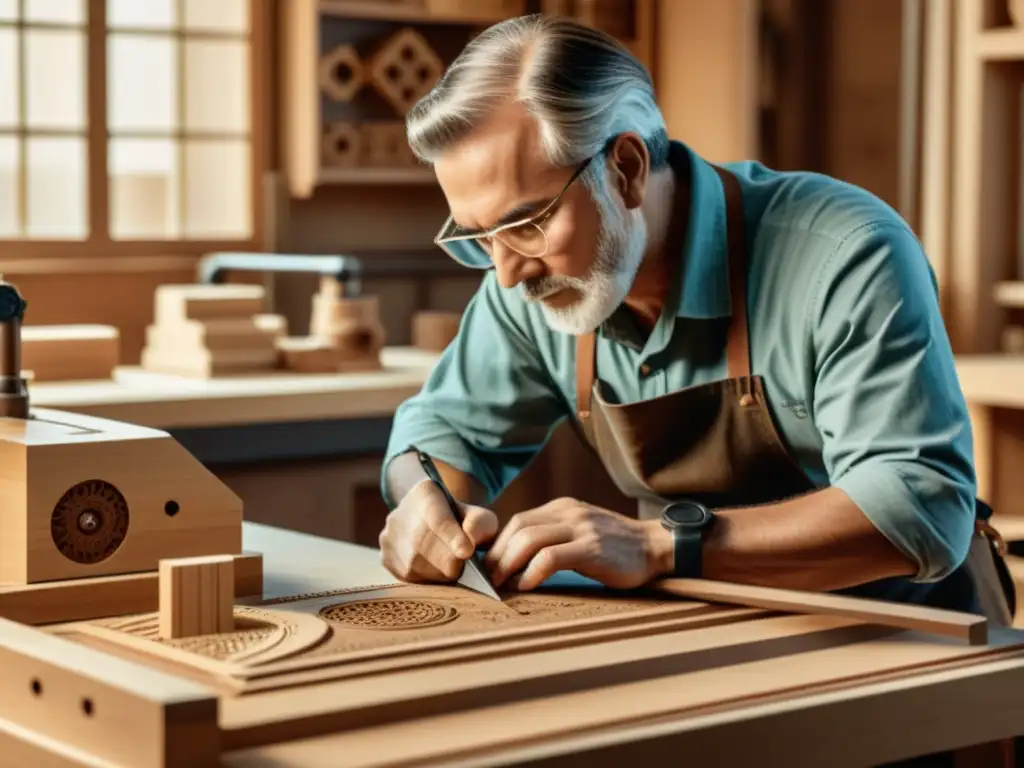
[160,555,234,640]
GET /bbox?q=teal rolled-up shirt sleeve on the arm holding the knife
[381,272,567,507]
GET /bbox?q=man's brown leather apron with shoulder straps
[577,167,1014,625]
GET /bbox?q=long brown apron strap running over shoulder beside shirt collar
[712,166,751,379]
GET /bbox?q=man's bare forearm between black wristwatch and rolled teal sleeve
[651,488,918,592]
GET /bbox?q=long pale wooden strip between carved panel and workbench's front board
[221,616,892,749]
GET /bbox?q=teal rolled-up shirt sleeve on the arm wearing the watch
[810,223,976,582]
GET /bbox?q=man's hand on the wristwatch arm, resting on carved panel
[483,499,672,591]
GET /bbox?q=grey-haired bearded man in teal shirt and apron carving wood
[380,16,1007,609]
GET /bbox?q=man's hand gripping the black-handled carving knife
[379,479,498,582]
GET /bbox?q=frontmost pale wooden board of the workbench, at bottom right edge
[224,633,1024,768]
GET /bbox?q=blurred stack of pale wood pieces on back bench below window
[141,285,287,377]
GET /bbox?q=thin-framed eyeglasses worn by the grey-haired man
[434,153,600,269]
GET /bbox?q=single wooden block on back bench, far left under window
[22,325,121,381]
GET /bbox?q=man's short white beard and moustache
[520,184,647,336]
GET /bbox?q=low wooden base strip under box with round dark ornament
[0,552,263,625]
